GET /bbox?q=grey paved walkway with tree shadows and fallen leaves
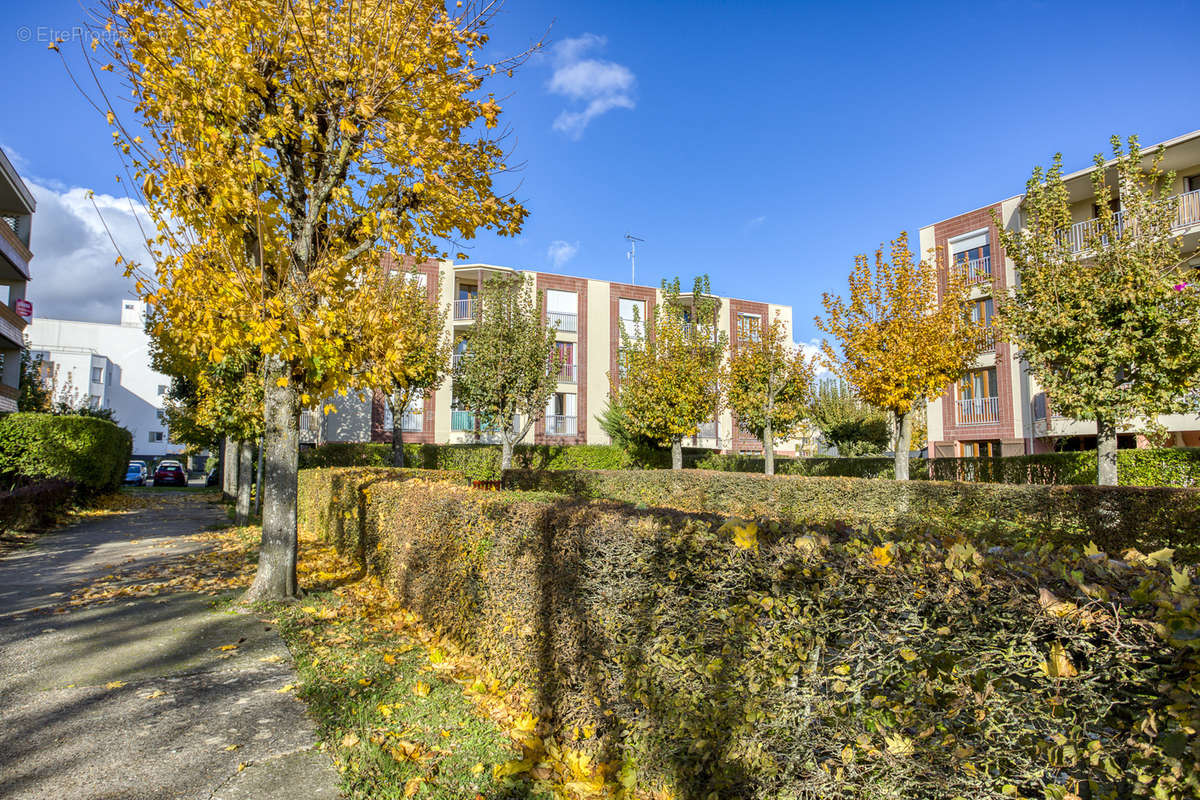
[0,495,338,800]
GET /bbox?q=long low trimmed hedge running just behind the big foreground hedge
[504,470,1200,557]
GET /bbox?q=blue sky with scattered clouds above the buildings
[0,0,1200,341]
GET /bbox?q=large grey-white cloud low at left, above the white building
[26,181,152,323]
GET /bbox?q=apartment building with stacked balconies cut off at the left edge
[0,150,37,413]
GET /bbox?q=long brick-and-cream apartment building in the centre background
[314,261,803,455]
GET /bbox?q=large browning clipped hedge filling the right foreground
[301,470,1200,800]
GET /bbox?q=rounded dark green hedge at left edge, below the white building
[0,413,133,493]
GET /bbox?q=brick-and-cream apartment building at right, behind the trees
[920,131,1200,457]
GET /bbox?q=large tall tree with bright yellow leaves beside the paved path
[82,0,526,600]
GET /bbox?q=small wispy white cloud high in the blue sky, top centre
[546,34,637,139]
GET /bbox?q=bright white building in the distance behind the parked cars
[28,300,182,458]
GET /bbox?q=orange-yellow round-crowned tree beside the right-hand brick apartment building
[816,234,984,480]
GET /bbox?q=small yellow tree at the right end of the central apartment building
[725,317,815,475]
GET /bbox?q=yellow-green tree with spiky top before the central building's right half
[608,280,728,469]
